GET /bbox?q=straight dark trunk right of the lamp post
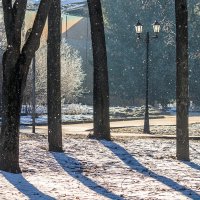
[175,0,189,160]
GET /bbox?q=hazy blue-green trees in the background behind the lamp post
[103,0,200,107]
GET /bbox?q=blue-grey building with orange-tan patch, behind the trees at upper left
[27,0,93,105]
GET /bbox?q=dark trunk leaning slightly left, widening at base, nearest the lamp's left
[87,0,110,140]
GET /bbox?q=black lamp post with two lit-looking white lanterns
[135,21,160,133]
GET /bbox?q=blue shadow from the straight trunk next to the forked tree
[52,152,124,200]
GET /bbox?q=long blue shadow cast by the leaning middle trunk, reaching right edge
[101,141,200,199]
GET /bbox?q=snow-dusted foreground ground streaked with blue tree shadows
[0,138,200,200]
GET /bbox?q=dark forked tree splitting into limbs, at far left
[0,0,51,173]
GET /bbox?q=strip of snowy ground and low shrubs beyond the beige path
[18,104,162,125]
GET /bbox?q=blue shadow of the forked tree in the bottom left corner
[0,171,55,200]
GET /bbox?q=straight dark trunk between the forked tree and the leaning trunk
[47,0,62,151]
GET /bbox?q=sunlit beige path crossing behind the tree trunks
[21,116,200,137]
